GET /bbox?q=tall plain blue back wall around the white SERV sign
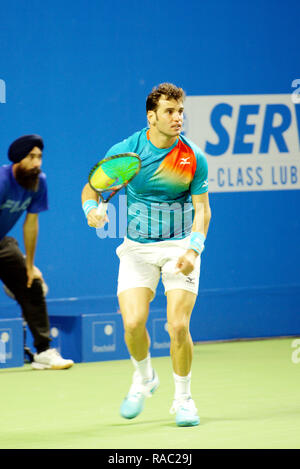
[0,0,300,348]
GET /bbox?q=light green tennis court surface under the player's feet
[0,338,300,449]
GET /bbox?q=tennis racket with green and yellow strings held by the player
[88,153,141,228]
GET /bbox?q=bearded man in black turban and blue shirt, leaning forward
[0,135,73,370]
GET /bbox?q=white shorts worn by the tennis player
[116,237,200,298]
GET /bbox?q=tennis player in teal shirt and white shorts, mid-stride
[82,83,211,426]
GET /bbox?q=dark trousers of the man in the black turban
[0,236,51,353]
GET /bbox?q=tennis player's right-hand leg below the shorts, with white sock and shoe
[167,289,200,426]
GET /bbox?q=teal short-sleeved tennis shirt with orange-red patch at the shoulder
[106,128,208,243]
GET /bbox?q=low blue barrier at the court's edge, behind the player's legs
[0,285,300,366]
